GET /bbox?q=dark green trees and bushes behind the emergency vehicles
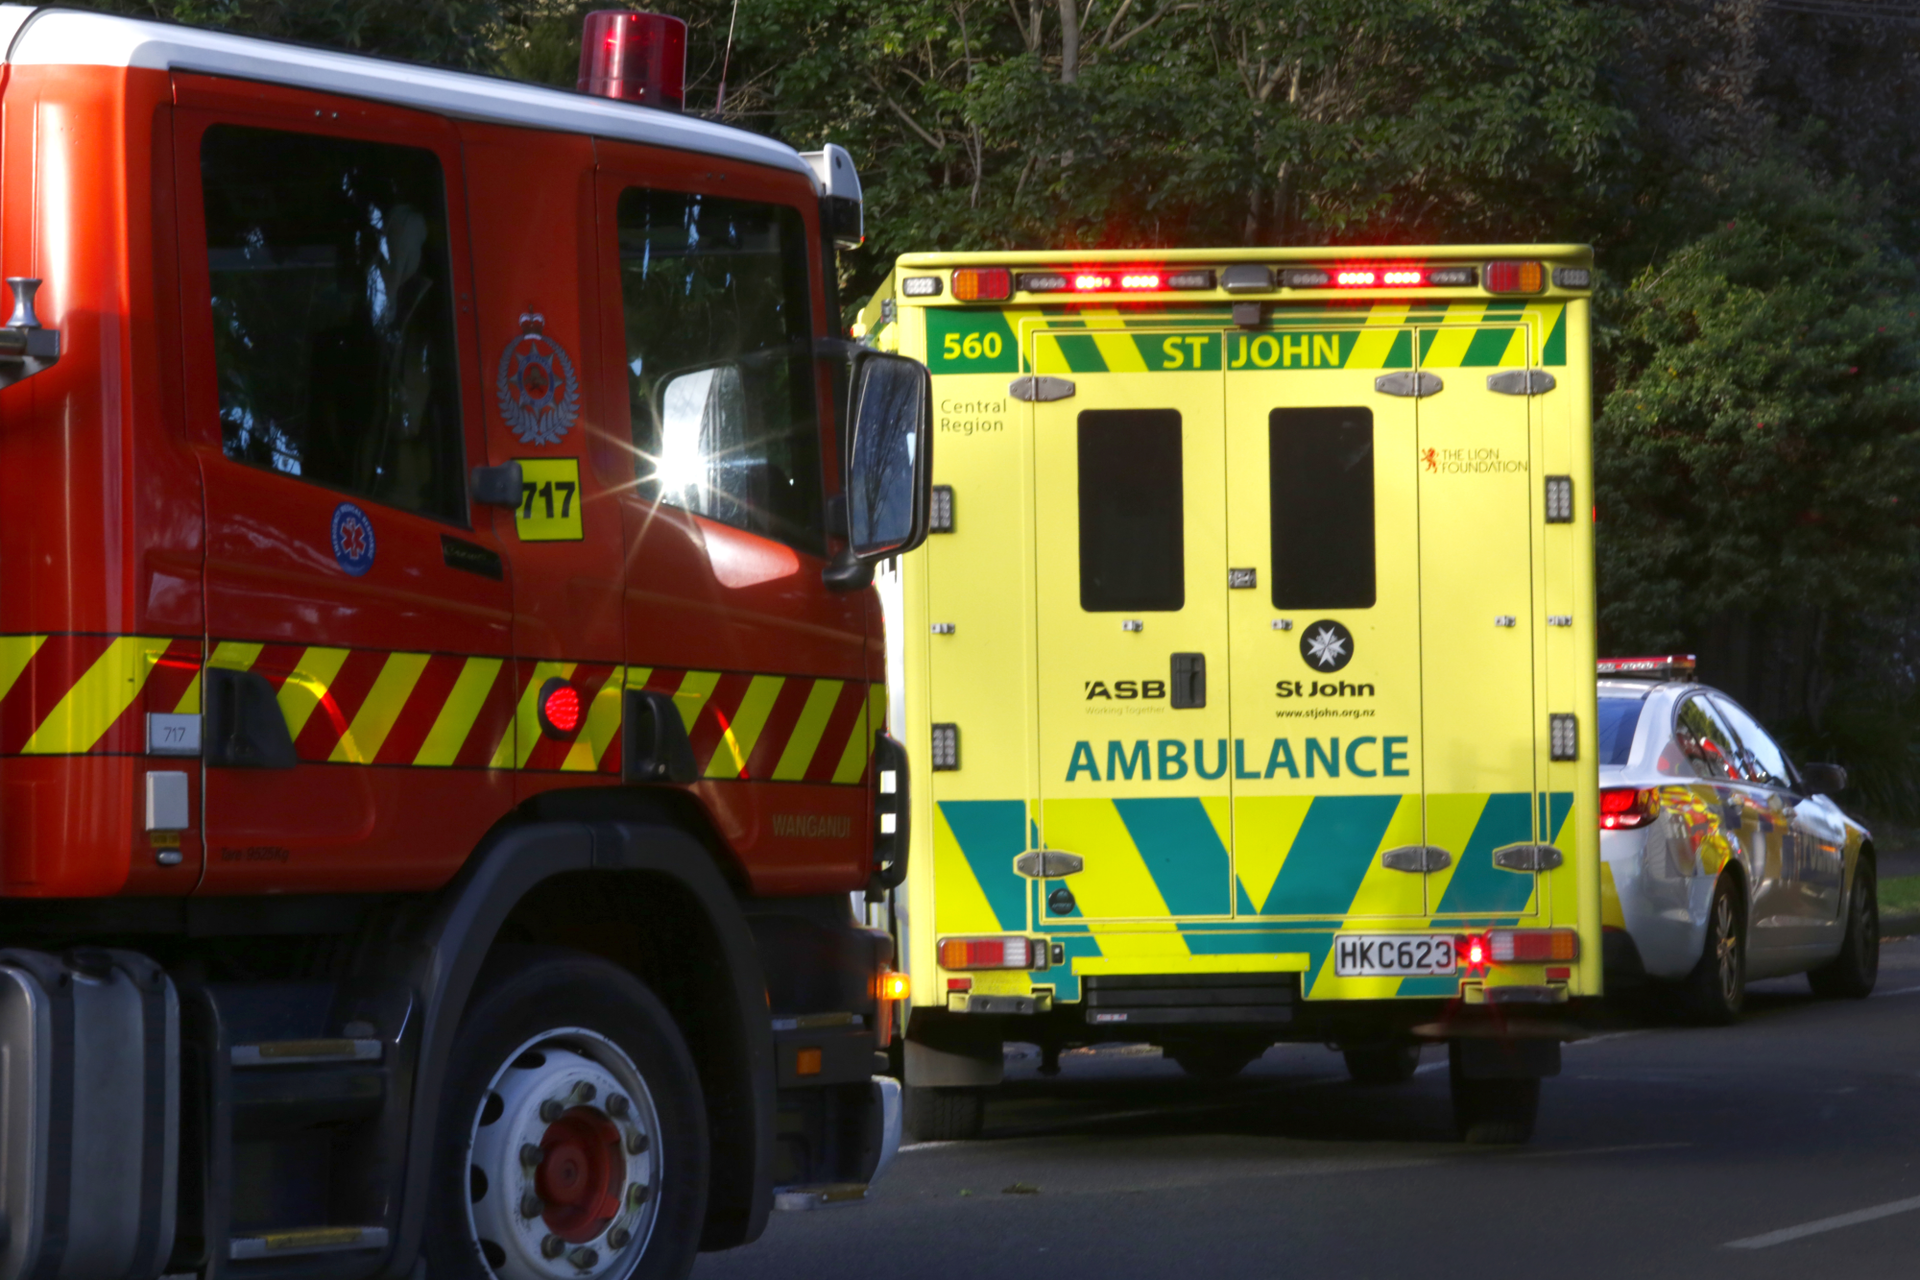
[86,0,1920,819]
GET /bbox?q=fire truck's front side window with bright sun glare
[618,188,826,553]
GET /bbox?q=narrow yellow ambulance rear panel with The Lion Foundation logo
[1413,324,1553,917]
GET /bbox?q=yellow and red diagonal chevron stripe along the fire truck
[0,635,885,785]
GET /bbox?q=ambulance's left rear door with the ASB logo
[1033,322,1233,921]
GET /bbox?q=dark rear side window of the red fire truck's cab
[200,125,467,524]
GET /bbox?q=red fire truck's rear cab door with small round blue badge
[175,75,513,892]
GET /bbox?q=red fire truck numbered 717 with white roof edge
[0,6,929,1280]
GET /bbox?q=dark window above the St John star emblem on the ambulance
[1267,409,1375,608]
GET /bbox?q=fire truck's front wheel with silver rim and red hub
[424,952,707,1280]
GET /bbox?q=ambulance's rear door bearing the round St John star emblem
[1225,324,1428,917]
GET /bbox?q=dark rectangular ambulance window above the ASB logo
[1079,409,1187,612]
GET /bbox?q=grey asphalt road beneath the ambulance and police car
[695,938,1920,1280]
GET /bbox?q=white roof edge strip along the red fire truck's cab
[0,4,818,186]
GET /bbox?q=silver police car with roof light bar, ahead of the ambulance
[1599,654,1880,1023]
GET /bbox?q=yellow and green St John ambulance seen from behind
[856,246,1601,1142]
